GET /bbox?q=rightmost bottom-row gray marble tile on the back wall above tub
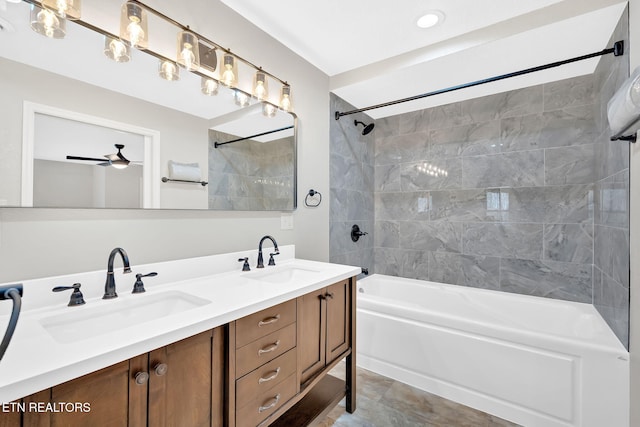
[500,258,593,303]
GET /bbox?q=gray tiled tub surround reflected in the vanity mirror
[208,130,294,210]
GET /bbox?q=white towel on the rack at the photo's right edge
[607,67,640,135]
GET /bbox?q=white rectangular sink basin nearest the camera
[40,291,211,343]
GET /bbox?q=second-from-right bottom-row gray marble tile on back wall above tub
[429,252,500,290]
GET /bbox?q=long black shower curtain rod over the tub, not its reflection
[335,40,624,120]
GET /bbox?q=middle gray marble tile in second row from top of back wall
[429,120,501,161]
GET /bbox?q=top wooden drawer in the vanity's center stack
[236,299,296,348]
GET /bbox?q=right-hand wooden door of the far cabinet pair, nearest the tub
[326,280,351,364]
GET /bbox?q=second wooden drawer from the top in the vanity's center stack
[236,323,296,378]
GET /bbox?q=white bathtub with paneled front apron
[356,274,629,427]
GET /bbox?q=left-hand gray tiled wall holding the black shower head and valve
[329,94,377,272]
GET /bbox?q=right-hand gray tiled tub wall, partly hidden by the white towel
[593,11,629,345]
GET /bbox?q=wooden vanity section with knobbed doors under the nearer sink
[0,327,225,427]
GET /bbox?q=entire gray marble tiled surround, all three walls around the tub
[331,14,629,345]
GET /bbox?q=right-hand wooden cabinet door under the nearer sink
[148,331,214,427]
